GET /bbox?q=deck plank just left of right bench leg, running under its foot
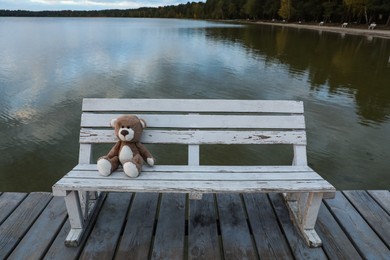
[269,193,327,259]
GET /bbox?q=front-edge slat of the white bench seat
[53,178,335,195]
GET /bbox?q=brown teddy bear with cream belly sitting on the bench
[97,115,155,178]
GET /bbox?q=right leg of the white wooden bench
[286,192,323,247]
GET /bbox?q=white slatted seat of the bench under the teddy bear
[53,164,334,197]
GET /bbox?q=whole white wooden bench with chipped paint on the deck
[53,99,335,247]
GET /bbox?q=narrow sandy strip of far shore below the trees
[236,21,390,39]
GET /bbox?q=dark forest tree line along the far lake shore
[0,0,390,26]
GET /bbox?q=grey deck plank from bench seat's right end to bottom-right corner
[325,192,390,259]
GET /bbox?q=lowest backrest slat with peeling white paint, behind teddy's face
[80,128,306,145]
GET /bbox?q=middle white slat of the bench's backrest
[81,112,305,129]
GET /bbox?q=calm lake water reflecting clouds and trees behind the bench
[0,18,390,191]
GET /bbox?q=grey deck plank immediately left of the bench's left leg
[8,197,67,260]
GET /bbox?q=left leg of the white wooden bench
[65,191,104,247]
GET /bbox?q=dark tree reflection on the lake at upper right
[206,26,390,124]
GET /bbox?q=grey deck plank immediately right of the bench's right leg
[316,203,362,260]
